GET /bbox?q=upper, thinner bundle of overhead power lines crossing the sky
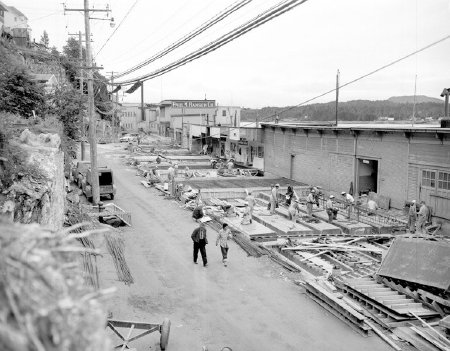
[116,0,252,77]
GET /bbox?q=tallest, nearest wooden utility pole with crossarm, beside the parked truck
[64,0,111,205]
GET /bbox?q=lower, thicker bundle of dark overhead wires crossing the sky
[114,0,308,85]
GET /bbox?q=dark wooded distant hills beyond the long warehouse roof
[241,96,444,122]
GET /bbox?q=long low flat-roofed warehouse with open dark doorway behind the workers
[262,123,450,221]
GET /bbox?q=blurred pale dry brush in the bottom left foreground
[0,222,111,351]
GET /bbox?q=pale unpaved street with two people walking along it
[98,144,390,351]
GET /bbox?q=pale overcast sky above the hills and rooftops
[8,0,450,107]
